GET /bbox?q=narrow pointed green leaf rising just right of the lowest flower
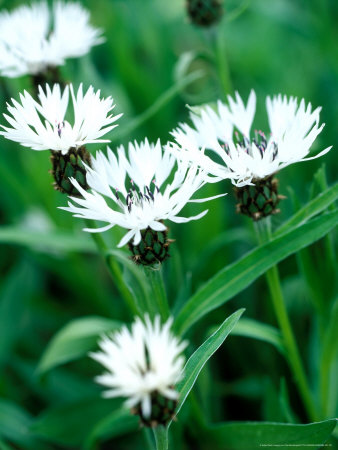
[176,309,244,413]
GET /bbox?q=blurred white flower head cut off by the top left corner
[0,1,103,77]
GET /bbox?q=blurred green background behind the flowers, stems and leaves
[0,0,338,449]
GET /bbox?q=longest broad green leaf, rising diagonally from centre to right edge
[175,211,338,335]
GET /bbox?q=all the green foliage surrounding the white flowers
[0,0,338,450]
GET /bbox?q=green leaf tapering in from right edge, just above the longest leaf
[273,183,338,237]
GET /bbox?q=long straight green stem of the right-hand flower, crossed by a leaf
[256,217,318,421]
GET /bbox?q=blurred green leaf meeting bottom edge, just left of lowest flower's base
[84,408,140,450]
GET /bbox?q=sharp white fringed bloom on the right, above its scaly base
[168,91,331,186]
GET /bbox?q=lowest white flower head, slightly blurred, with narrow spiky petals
[90,315,187,418]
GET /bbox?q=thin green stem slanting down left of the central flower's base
[84,219,139,315]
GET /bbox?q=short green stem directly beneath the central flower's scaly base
[144,267,170,322]
